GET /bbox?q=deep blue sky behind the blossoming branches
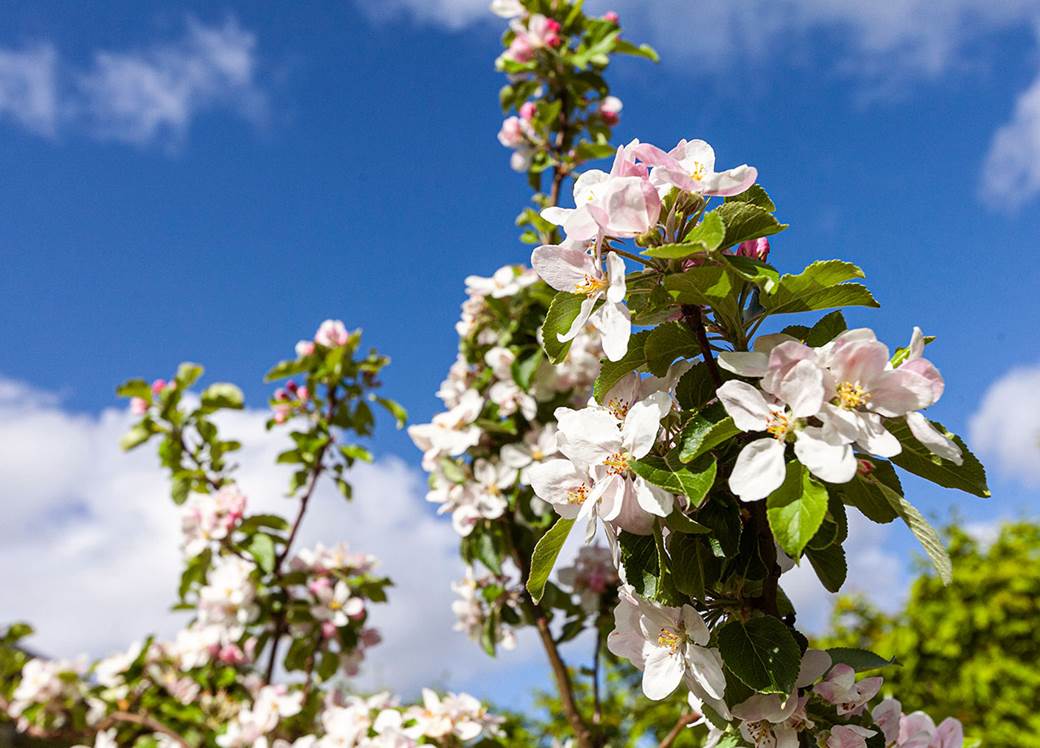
[0,0,1040,707]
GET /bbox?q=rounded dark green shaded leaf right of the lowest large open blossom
[718,616,802,696]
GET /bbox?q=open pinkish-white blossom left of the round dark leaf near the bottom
[606,587,726,700]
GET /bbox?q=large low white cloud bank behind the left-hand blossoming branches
[0,380,540,692]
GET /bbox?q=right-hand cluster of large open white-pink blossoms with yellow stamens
[718,328,962,501]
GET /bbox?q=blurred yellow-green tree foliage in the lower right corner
[818,521,1040,748]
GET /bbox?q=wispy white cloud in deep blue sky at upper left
[0,19,265,146]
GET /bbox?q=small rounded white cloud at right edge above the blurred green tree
[969,364,1040,486]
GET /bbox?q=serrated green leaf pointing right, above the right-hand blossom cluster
[761,260,879,314]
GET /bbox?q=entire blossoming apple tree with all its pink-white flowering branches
[0,0,989,748]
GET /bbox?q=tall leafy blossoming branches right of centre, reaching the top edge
[411,0,989,748]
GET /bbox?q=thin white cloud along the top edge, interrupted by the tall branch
[357,0,1040,77]
